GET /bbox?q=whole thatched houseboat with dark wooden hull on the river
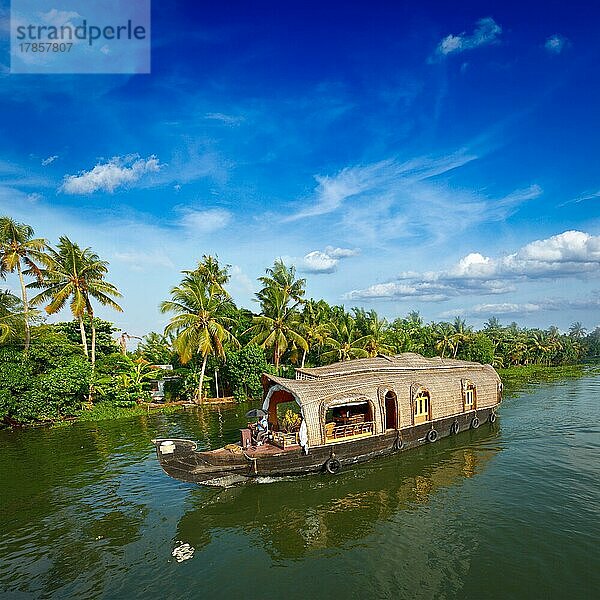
[154,353,502,485]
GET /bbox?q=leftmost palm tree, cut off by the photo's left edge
[0,217,46,352]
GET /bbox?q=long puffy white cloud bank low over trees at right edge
[347,231,600,300]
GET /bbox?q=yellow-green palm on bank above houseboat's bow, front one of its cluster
[160,272,239,402]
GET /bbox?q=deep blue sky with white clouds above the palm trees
[0,0,600,335]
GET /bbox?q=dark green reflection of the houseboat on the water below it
[174,424,501,558]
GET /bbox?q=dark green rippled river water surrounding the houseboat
[0,375,600,599]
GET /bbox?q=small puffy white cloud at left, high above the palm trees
[60,155,162,194]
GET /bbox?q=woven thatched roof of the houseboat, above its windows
[263,353,499,406]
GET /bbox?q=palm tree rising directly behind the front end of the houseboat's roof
[248,288,308,370]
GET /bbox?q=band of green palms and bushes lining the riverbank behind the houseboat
[0,217,600,426]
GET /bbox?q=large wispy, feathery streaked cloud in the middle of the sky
[282,148,542,247]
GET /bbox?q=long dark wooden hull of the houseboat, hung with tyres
[153,408,495,486]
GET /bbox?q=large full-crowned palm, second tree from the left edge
[28,236,123,367]
